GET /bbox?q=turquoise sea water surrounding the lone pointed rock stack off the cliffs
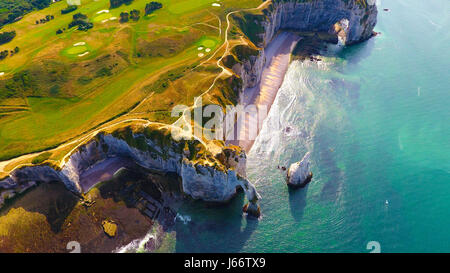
[176,0,450,252]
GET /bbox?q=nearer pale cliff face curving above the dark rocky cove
[0,127,260,207]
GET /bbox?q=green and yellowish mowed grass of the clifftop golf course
[0,0,261,161]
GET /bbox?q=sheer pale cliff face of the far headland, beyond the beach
[260,0,378,46]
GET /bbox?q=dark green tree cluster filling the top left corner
[0,0,52,27]
